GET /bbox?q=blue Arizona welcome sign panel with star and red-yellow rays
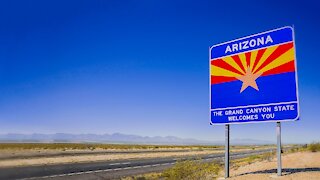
[209,27,299,124]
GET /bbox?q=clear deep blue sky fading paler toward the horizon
[0,0,320,143]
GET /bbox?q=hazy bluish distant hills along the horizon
[0,133,272,145]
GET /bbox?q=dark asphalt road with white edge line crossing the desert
[0,149,275,180]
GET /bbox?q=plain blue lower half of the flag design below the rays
[211,72,297,109]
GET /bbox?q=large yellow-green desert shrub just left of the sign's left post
[162,160,221,180]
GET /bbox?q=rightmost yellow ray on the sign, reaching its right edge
[258,48,294,73]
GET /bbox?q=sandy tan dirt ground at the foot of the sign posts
[223,152,320,180]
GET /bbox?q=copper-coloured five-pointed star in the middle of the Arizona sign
[236,67,262,93]
